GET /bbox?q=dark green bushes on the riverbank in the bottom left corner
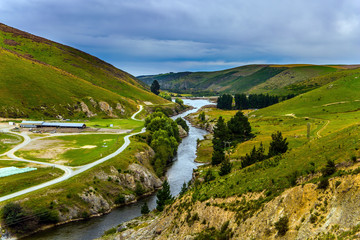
[1,202,59,233]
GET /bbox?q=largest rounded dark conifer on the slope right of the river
[227,111,251,141]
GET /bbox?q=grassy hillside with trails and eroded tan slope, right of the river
[109,70,360,239]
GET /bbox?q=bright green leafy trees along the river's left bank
[145,110,181,176]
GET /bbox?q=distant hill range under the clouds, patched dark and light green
[138,64,359,94]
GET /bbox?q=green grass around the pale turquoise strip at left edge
[0,160,63,196]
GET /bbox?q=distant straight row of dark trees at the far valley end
[217,93,295,110]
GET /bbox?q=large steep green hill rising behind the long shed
[0,24,166,118]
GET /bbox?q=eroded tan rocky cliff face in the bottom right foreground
[103,174,360,240]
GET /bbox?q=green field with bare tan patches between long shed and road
[16,134,125,166]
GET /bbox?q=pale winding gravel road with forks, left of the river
[0,105,146,202]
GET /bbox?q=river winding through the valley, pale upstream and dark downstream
[25,99,211,240]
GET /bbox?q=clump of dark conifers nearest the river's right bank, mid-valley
[211,111,252,175]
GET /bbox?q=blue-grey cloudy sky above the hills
[0,0,360,76]
